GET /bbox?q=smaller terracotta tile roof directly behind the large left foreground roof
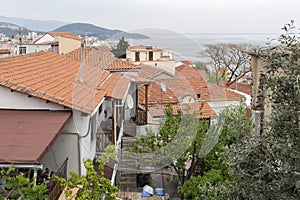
[65,45,139,71]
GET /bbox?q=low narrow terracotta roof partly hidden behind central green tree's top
[149,102,216,119]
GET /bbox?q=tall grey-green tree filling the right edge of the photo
[231,22,300,200]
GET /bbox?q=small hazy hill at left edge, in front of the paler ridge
[0,22,43,37]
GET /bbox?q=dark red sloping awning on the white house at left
[0,110,71,164]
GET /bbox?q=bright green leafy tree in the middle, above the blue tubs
[132,105,208,185]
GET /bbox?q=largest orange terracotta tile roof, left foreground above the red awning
[0,52,109,113]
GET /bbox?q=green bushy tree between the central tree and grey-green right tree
[180,105,253,199]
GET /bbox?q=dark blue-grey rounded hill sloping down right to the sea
[54,23,148,40]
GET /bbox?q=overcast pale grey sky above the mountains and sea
[0,0,300,33]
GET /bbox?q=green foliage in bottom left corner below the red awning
[0,166,49,200]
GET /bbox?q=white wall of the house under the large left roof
[0,86,105,174]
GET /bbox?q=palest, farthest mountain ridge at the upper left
[0,15,69,32]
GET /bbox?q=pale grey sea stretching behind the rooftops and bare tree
[122,29,280,62]
